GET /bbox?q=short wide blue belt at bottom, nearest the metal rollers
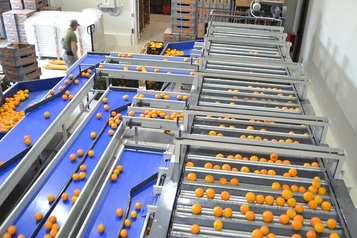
[85,150,167,237]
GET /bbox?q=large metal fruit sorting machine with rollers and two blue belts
[0,22,357,238]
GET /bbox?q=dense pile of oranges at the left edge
[0,89,30,132]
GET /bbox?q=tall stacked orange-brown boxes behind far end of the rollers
[164,0,232,43]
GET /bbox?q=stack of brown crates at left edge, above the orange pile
[0,44,41,82]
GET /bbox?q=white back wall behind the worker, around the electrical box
[51,0,133,50]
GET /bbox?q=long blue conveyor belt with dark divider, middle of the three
[10,91,135,237]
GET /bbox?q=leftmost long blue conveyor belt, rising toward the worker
[0,55,105,175]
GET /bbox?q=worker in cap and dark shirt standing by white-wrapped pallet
[62,20,79,69]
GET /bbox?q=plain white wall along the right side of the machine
[300,0,357,206]
